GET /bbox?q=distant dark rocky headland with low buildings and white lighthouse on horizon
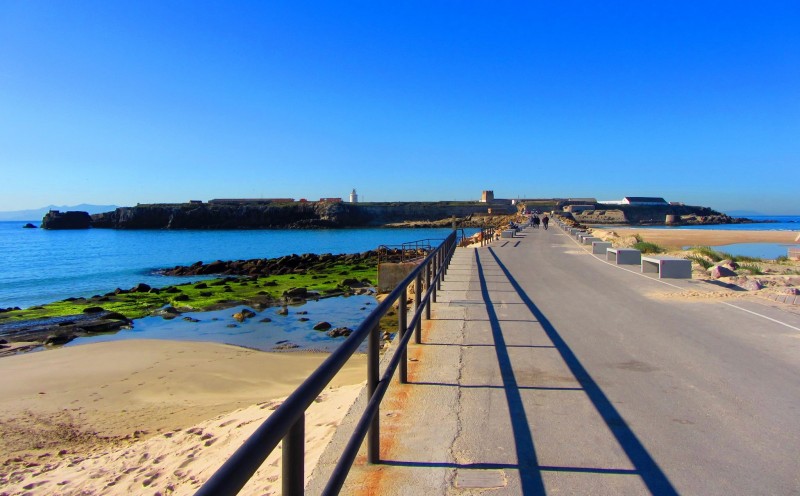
[37,191,748,230]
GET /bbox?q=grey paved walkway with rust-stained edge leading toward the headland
[309,227,800,495]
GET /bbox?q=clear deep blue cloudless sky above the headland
[0,0,800,214]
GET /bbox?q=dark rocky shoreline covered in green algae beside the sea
[0,251,378,356]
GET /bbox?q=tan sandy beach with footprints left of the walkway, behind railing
[0,340,366,495]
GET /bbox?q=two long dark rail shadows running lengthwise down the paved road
[484,247,678,496]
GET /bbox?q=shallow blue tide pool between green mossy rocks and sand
[66,295,377,351]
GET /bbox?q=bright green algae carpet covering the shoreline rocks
[0,264,377,323]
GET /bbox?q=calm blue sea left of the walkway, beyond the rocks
[0,222,475,308]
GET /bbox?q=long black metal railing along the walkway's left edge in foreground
[196,231,457,496]
